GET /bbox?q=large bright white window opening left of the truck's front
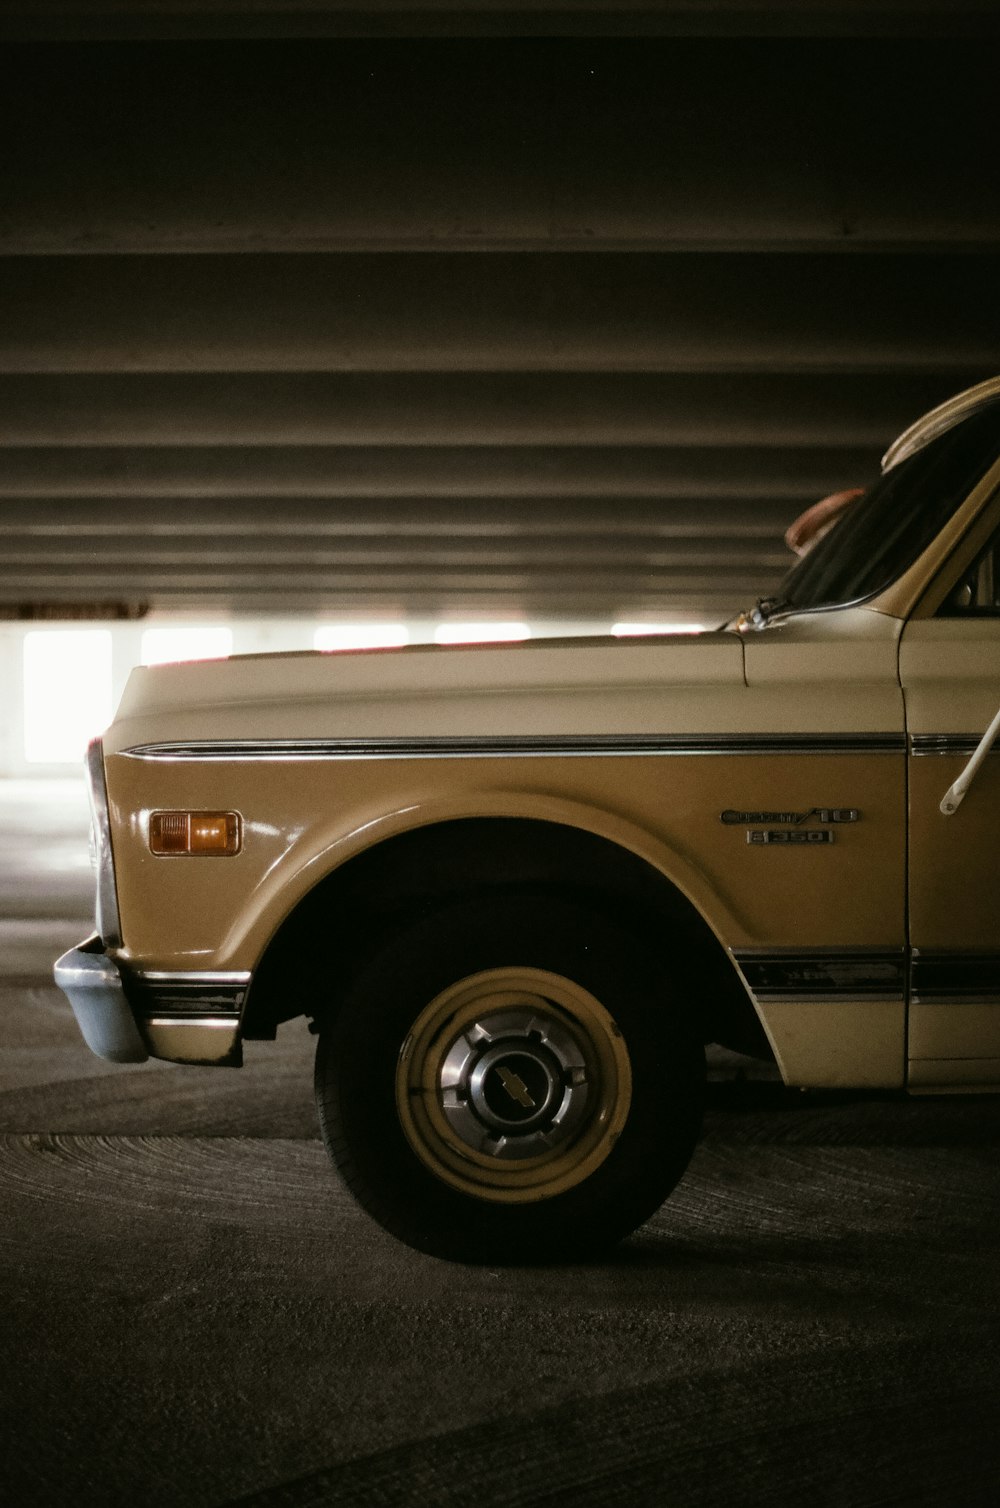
[24,629,115,765]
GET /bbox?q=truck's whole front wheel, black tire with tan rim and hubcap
[315,896,704,1264]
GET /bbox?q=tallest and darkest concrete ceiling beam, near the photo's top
[0,38,1000,253]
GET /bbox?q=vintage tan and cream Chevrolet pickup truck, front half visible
[56,379,1000,1261]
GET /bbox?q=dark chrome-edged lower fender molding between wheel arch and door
[732,949,906,1003]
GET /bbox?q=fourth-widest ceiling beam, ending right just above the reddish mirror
[0,445,876,500]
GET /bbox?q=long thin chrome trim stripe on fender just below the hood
[124,733,906,762]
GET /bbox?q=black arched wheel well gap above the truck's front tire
[244,817,771,1057]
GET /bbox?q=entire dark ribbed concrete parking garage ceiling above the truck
[0,0,1000,621]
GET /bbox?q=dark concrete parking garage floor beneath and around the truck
[0,786,1000,1508]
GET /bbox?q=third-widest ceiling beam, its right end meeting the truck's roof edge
[0,368,971,452]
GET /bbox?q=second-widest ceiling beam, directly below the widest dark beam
[0,252,1000,374]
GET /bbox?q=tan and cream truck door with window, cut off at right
[899,512,1000,1092]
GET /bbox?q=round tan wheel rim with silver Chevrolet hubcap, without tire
[395,968,632,1203]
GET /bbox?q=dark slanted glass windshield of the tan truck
[771,404,1000,612]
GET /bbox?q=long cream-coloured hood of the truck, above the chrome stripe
[104,632,745,754]
